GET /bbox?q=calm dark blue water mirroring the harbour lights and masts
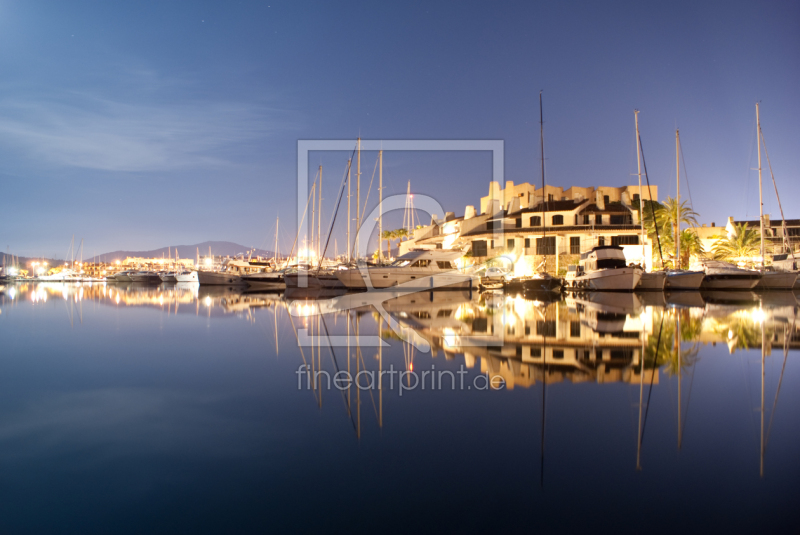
[0,284,800,534]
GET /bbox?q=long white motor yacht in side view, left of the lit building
[334,249,480,291]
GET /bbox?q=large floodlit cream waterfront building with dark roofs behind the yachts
[400,181,658,277]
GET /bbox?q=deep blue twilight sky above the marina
[0,0,800,256]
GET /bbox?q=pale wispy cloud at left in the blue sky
[0,82,287,171]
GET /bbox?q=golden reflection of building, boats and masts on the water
[0,283,800,482]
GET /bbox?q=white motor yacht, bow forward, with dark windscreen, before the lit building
[566,245,643,292]
